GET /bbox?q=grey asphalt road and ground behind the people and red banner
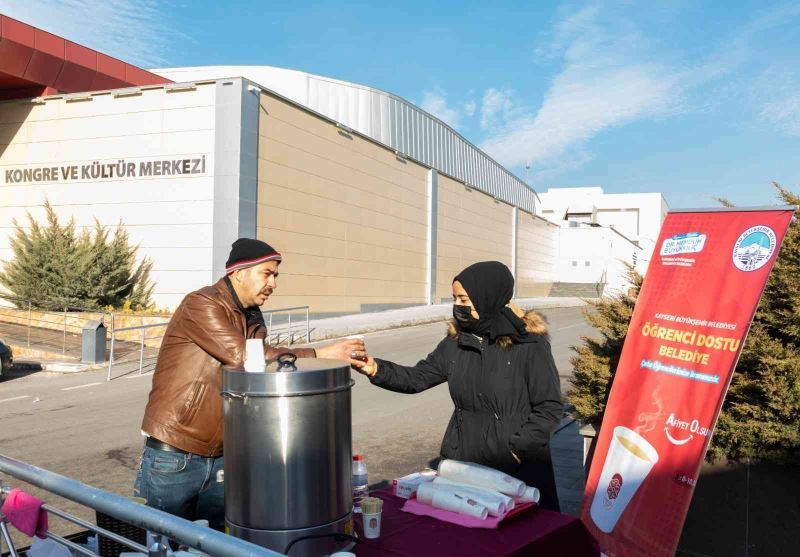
[0,308,800,557]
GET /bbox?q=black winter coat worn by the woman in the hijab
[370,314,563,510]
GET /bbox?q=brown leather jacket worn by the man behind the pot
[142,279,315,456]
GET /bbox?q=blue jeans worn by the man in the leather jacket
[133,446,225,531]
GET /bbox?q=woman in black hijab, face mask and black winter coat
[359,261,563,510]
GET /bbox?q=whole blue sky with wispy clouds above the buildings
[0,0,800,207]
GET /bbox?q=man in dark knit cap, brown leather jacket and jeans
[134,238,366,529]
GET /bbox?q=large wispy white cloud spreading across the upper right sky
[481,2,800,184]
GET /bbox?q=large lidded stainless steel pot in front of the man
[222,354,353,556]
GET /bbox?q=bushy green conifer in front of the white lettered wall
[0,201,153,309]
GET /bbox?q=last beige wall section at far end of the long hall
[516,211,559,298]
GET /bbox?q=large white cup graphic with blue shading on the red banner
[590,426,658,534]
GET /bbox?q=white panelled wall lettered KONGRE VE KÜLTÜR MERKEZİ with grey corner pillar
[0,80,258,308]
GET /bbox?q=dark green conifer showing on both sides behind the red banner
[567,184,800,461]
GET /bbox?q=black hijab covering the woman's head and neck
[453,261,527,341]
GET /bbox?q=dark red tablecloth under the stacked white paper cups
[351,488,600,557]
